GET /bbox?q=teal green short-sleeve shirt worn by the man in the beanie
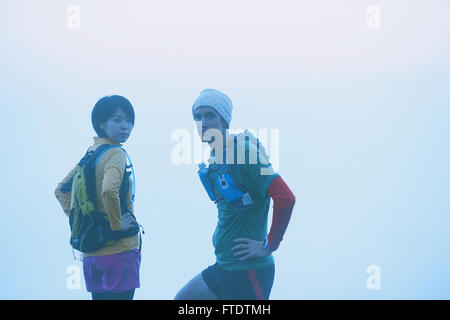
[209,134,278,271]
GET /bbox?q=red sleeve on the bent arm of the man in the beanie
[267,176,295,250]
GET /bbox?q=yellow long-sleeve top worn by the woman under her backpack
[55,137,139,257]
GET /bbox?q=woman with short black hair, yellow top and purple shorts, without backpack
[55,95,141,300]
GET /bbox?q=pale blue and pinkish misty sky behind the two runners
[0,0,450,299]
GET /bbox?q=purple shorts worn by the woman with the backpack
[83,249,141,293]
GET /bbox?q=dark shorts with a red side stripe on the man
[202,263,275,300]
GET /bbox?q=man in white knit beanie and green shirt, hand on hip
[175,89,295,300]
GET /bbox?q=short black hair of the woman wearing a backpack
[91,95,134,138]
